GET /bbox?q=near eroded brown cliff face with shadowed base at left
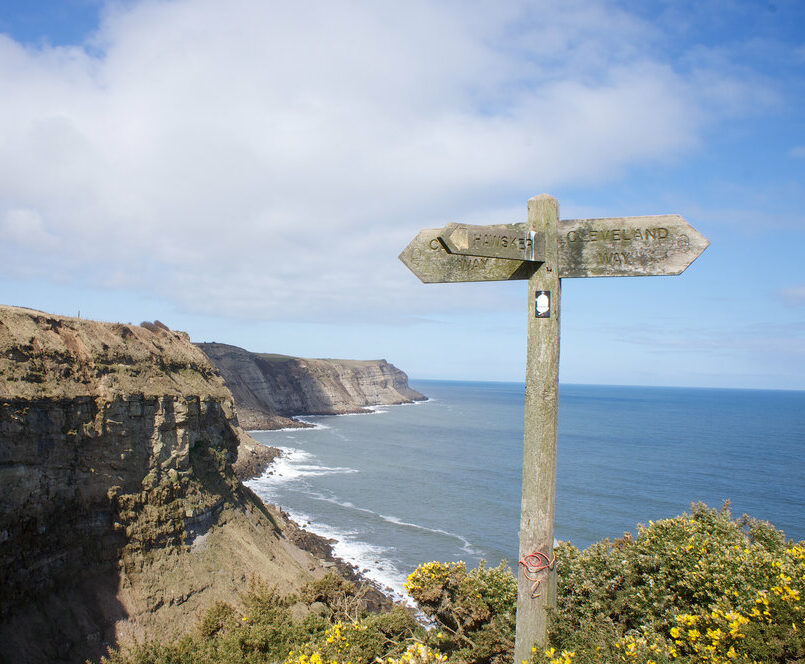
[0,307,324,662]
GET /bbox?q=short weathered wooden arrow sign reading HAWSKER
[440,224,545,261]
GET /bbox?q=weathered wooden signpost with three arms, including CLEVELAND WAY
[400,194,709,664]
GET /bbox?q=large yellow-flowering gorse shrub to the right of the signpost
[535,504,805,664]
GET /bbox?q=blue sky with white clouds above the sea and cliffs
[0,0,805,389]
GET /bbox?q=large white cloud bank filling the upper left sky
[0,0,768,318]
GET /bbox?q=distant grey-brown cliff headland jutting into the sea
[196,343,426,429]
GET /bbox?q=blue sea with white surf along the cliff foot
[243,380,805,599]
